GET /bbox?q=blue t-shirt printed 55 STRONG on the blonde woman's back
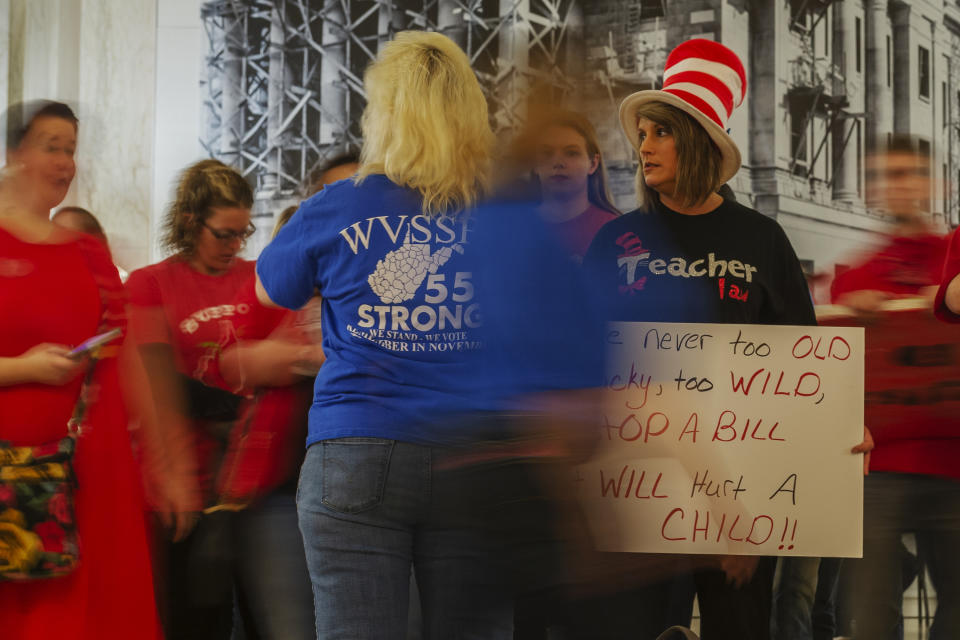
[257,175,488,445]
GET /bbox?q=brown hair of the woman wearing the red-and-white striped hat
[634,102,723,210]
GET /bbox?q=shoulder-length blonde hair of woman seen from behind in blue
[356,31,494,214]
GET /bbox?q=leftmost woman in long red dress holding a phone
[0,101,160,640]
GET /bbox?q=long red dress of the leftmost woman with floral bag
[0,228,161,640]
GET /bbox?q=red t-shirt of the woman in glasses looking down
[127,256,255,391]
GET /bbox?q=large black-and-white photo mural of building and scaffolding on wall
[195,0,960,304]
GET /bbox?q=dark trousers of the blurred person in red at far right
[850,472,960,640]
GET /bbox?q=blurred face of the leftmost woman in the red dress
[9,116,77,209]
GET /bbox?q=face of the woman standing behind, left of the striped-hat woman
[534,125,600,198]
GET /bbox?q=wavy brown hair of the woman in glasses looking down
[161,160,253,255]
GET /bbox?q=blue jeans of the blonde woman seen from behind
[297,438,513,640]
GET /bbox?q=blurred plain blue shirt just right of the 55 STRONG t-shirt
[469,202,604,411]
